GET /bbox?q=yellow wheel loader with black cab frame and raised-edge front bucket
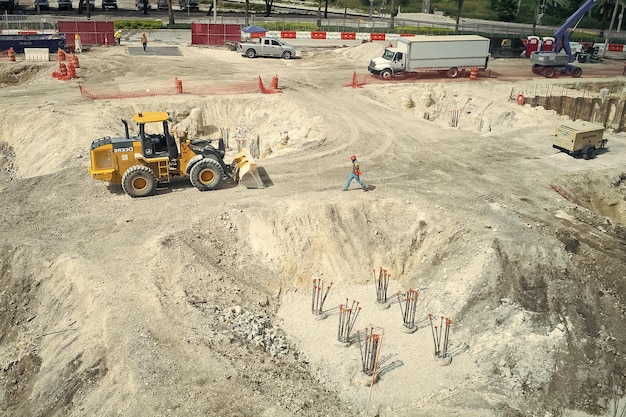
[89,112,264,197]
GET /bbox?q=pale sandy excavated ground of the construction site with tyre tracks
[0,33,626,417]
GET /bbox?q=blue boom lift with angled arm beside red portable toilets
[530,0,596,78]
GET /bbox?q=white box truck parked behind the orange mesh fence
[367,35,489,79]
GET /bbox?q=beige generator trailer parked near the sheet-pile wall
[552,121,607,159]
